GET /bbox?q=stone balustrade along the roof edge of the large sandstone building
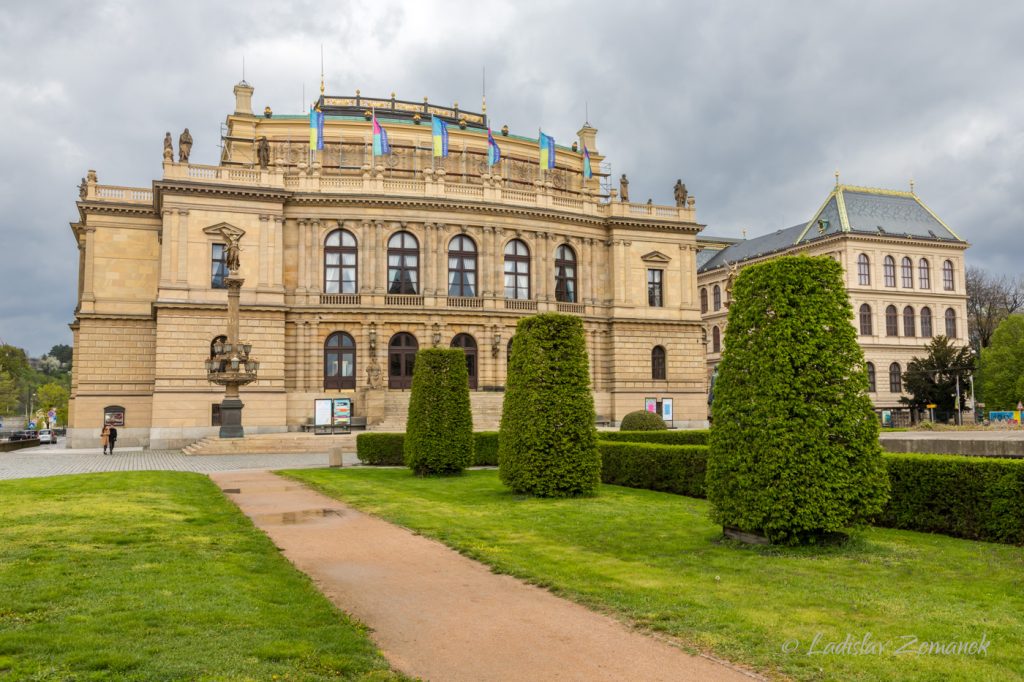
[86,162,696,222]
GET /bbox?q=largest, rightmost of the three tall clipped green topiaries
[707,256,888,544]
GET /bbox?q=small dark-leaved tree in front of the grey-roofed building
[900,336,974,414]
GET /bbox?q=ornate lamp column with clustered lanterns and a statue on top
[206,230,259,438]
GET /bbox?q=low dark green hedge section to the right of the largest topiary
[877,454,1024,545]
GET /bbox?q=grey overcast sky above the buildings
[0,0,1024,354]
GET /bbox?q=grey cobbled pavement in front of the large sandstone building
[0,445,339,480]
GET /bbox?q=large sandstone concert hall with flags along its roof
[69,83,707,446]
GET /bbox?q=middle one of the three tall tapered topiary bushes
[498,313,601,497]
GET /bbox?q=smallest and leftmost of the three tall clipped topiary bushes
[406,348,473,476]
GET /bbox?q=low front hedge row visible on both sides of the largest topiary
[599,440,1024,545]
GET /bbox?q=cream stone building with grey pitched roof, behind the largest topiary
[697,184,969,421]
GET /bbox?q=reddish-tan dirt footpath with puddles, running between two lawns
[210,471,753,682]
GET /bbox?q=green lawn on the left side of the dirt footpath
[0,472,396,680]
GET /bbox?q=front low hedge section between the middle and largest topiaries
[597,440,708,498]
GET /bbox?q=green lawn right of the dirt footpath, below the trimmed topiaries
[287,469,1024,680]
